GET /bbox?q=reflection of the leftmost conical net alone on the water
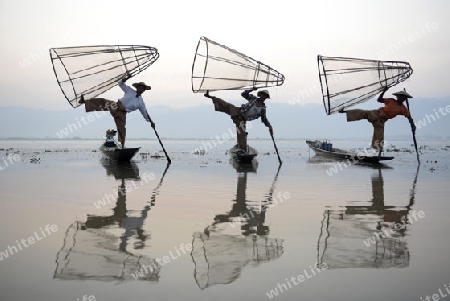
[54,222,160,282]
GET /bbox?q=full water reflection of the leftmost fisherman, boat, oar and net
[53,160,169,282]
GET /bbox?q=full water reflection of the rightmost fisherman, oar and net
[317,167,419,269]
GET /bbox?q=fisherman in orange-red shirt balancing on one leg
[339,87,416,156]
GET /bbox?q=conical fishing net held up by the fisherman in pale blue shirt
[50,45,159,108]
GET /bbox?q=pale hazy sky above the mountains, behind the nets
[0,0,450,110]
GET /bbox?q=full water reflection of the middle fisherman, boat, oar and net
[191,160,283,289]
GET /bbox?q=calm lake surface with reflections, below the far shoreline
[0,140,450,301]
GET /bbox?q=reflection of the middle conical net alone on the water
[191,233,283,289]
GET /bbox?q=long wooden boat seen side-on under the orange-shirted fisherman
[306,140,394,163]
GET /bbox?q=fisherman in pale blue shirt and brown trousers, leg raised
[78,76,155,148]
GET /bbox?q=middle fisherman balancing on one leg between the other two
[204,88,273,153]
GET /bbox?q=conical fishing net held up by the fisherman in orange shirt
[317,55,413,115]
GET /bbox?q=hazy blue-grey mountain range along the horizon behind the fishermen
[0,97,450,140]
